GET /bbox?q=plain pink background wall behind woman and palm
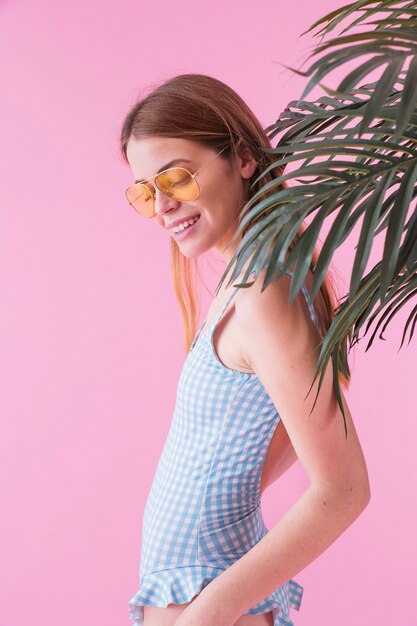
[0,0,417,626]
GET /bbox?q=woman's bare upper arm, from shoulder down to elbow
[236,270,369,497]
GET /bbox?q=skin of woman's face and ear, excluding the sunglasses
[126,137,256,262]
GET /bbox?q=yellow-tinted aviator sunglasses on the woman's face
[125,146,227,217]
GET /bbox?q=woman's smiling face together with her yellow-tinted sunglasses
[126,136,247,258]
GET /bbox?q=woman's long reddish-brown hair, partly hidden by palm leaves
[120,74,349,387]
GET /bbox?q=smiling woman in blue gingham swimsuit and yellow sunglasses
[121,74,370,626]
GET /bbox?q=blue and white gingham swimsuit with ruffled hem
[129,270,318,626]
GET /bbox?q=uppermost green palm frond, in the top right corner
[296,0,417,137]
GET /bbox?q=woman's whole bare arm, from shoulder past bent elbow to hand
[179,275,370,625]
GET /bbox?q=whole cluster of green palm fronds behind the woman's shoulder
[216,0,417,434]
